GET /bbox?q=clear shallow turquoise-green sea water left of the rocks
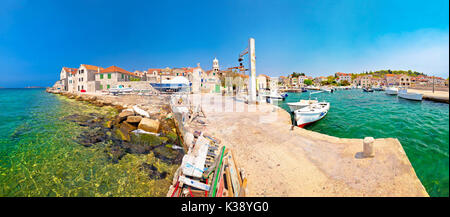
[0,89,178,196]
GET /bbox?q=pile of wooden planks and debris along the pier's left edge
[167,95,247,197]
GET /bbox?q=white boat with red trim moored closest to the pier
[294,102,330,128]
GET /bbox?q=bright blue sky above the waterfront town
[0,0,449,87]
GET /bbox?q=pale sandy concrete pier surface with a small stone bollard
[192,96,428,196]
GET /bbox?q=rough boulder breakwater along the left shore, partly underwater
[47,90,184,179]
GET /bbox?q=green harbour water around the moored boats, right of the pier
[279,89,449,197]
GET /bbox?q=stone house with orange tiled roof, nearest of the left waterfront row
[95,66,139,91]
